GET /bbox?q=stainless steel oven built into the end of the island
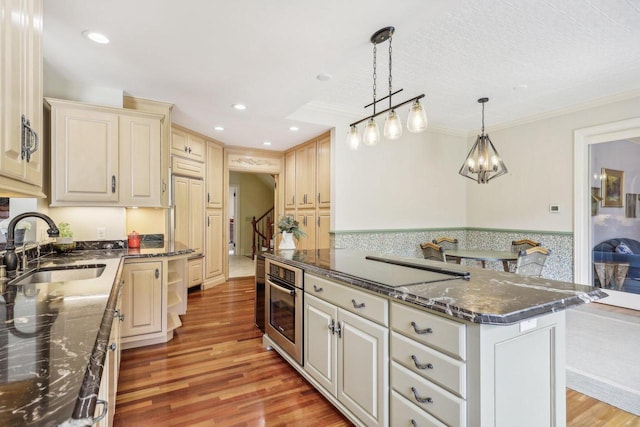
[265,259,304,365]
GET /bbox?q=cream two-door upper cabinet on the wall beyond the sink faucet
[46,99,164,207]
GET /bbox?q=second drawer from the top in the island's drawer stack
[391,332,467,398]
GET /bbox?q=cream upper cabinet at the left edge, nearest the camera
[0,0,44,197]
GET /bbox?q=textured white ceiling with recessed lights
[44,0,640,150]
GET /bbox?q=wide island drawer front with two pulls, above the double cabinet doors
[304,274,389,326]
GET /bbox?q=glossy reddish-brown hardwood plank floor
[114,278,640,427]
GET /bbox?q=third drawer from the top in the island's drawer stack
[391,362,467,426]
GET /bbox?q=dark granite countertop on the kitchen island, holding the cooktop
[264,249,607,325]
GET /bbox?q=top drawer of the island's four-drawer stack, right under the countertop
[391,303,467,360]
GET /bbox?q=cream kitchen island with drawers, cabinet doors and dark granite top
[264,249,606,426]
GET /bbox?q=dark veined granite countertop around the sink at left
[0,244,192,426]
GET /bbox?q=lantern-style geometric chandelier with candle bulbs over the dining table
[458,98,508,184]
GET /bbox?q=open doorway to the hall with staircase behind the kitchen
[228,171,275,278]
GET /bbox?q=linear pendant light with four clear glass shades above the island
[347,27,427,150]
